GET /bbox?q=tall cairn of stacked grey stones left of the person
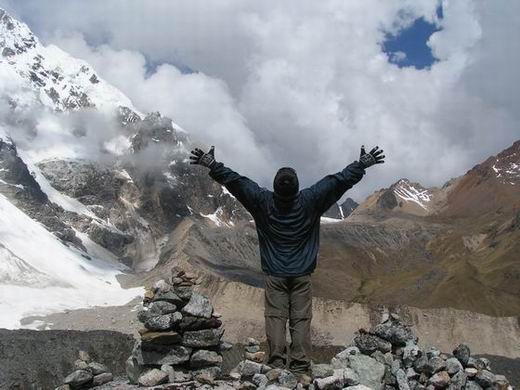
[127,267,224,386]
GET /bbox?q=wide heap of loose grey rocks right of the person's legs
[306,315,512,390]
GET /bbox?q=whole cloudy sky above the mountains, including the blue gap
[0,0,520,200]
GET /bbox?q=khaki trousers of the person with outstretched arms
[264,275,312,373]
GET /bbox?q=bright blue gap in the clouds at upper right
[382,7,443,69]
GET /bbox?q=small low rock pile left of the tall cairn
[56,351,114,390]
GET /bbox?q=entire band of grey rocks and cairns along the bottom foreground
[45,267,513,390]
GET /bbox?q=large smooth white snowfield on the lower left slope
[0,195,143,329]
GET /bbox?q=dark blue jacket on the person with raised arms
[209,161,365,277]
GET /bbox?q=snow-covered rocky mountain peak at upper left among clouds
[0,9,140,115]
